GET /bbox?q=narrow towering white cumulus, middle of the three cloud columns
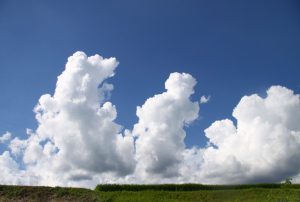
[133,73,199,181]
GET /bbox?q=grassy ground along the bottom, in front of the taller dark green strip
[0,185,300,202]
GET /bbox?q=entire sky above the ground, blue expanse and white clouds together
[0,0,300,187]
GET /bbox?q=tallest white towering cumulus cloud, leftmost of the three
[3,52,134,188]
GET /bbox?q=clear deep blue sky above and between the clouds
[0,0,300,150]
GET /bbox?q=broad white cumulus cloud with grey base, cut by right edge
[199,86,300,183]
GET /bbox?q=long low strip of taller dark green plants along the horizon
[95,184,282,192]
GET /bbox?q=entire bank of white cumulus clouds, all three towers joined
[0,52,300,187]
